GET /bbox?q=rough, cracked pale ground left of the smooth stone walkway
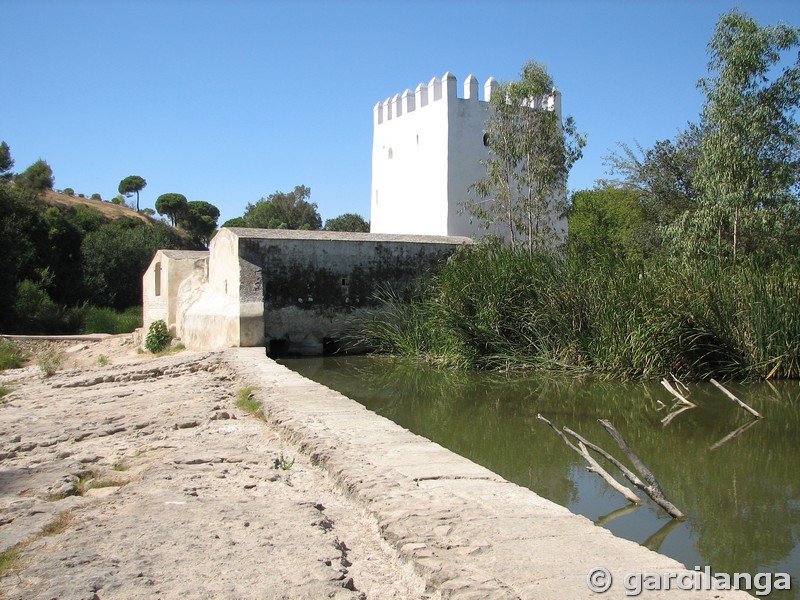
[0,336,435,600]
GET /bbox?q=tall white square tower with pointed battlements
[370,72,561,237]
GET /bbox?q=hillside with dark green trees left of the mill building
[0,142,202,334]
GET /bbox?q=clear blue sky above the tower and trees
[0,0,800,222]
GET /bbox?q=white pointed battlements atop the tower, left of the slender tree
[373,71,499,125]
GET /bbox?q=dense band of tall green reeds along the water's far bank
[353,244,800,379]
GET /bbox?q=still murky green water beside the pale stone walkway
[283,357,800,599]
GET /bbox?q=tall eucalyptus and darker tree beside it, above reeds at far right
[598,10,800,265]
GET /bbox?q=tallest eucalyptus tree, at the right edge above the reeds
[692,10,800,265]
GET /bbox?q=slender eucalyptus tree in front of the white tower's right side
[466,61,585,253]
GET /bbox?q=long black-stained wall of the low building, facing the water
[231,228,471,354]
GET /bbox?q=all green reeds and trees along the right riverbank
[356,10,800,379]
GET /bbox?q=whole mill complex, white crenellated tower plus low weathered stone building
[143,73,561,355]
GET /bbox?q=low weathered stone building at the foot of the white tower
[144,228,472,355]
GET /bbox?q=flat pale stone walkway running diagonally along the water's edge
[223,348,751,600]
